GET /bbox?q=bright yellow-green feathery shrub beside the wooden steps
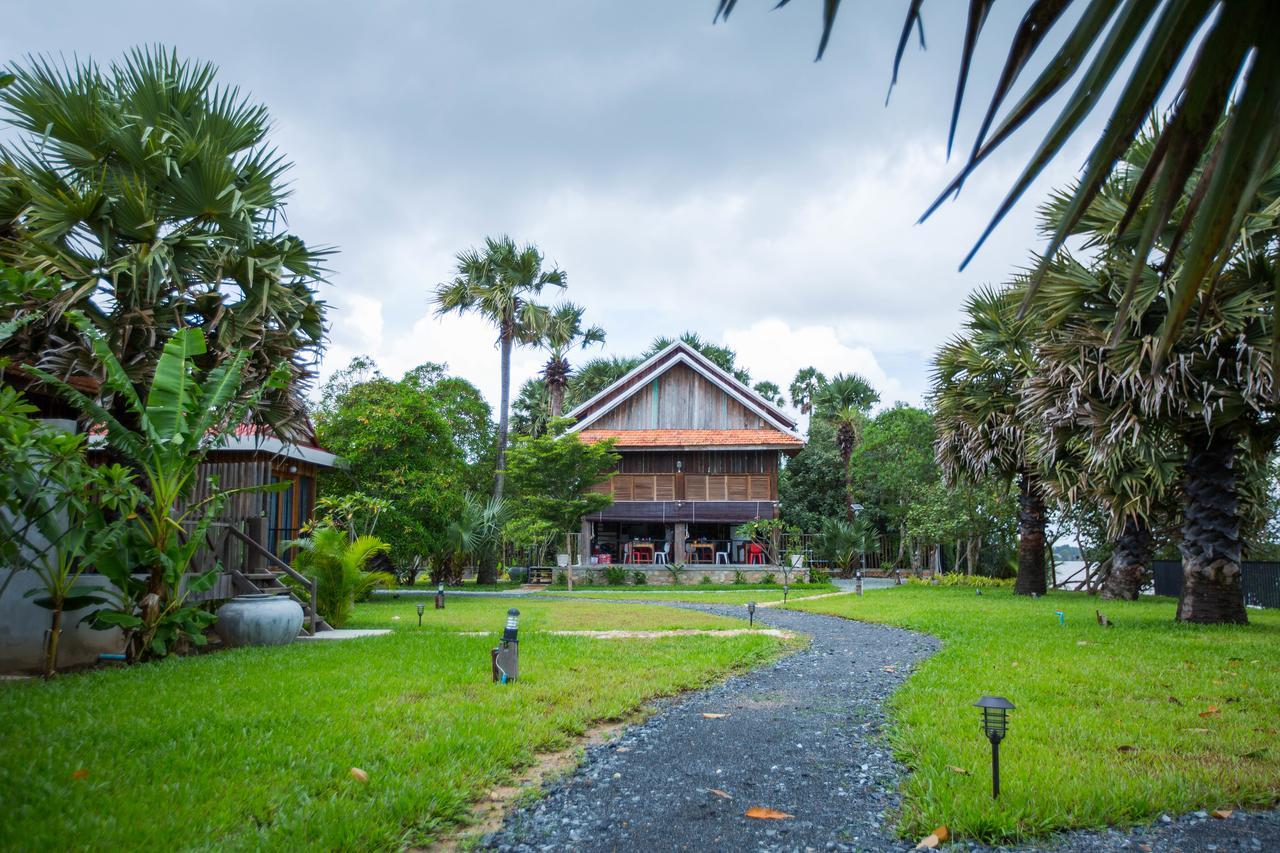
[285,526,394,628]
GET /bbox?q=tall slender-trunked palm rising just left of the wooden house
[435,236,566,501]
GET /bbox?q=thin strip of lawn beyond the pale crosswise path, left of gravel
[346,596,742,637]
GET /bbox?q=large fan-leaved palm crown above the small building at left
[0,50,328,437]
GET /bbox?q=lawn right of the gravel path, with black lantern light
[792,587,1280,841]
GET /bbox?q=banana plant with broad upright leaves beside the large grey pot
[28,315,288,661]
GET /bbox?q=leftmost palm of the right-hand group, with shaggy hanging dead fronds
[932,288,1048,596]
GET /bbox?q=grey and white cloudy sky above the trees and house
[0,0,1105,414]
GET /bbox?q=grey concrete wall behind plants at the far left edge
[0,571,124,672]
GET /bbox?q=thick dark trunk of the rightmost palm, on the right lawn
[1178,429,1249,625]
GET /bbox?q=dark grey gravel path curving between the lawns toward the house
[484,605,938,850]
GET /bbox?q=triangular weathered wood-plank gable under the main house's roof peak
[591,364,772,429]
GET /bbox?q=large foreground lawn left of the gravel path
[0,599,782,850]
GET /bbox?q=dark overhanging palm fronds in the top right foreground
[717,0,1280,365]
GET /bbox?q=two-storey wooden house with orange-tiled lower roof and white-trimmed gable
[568,342,804,566]
